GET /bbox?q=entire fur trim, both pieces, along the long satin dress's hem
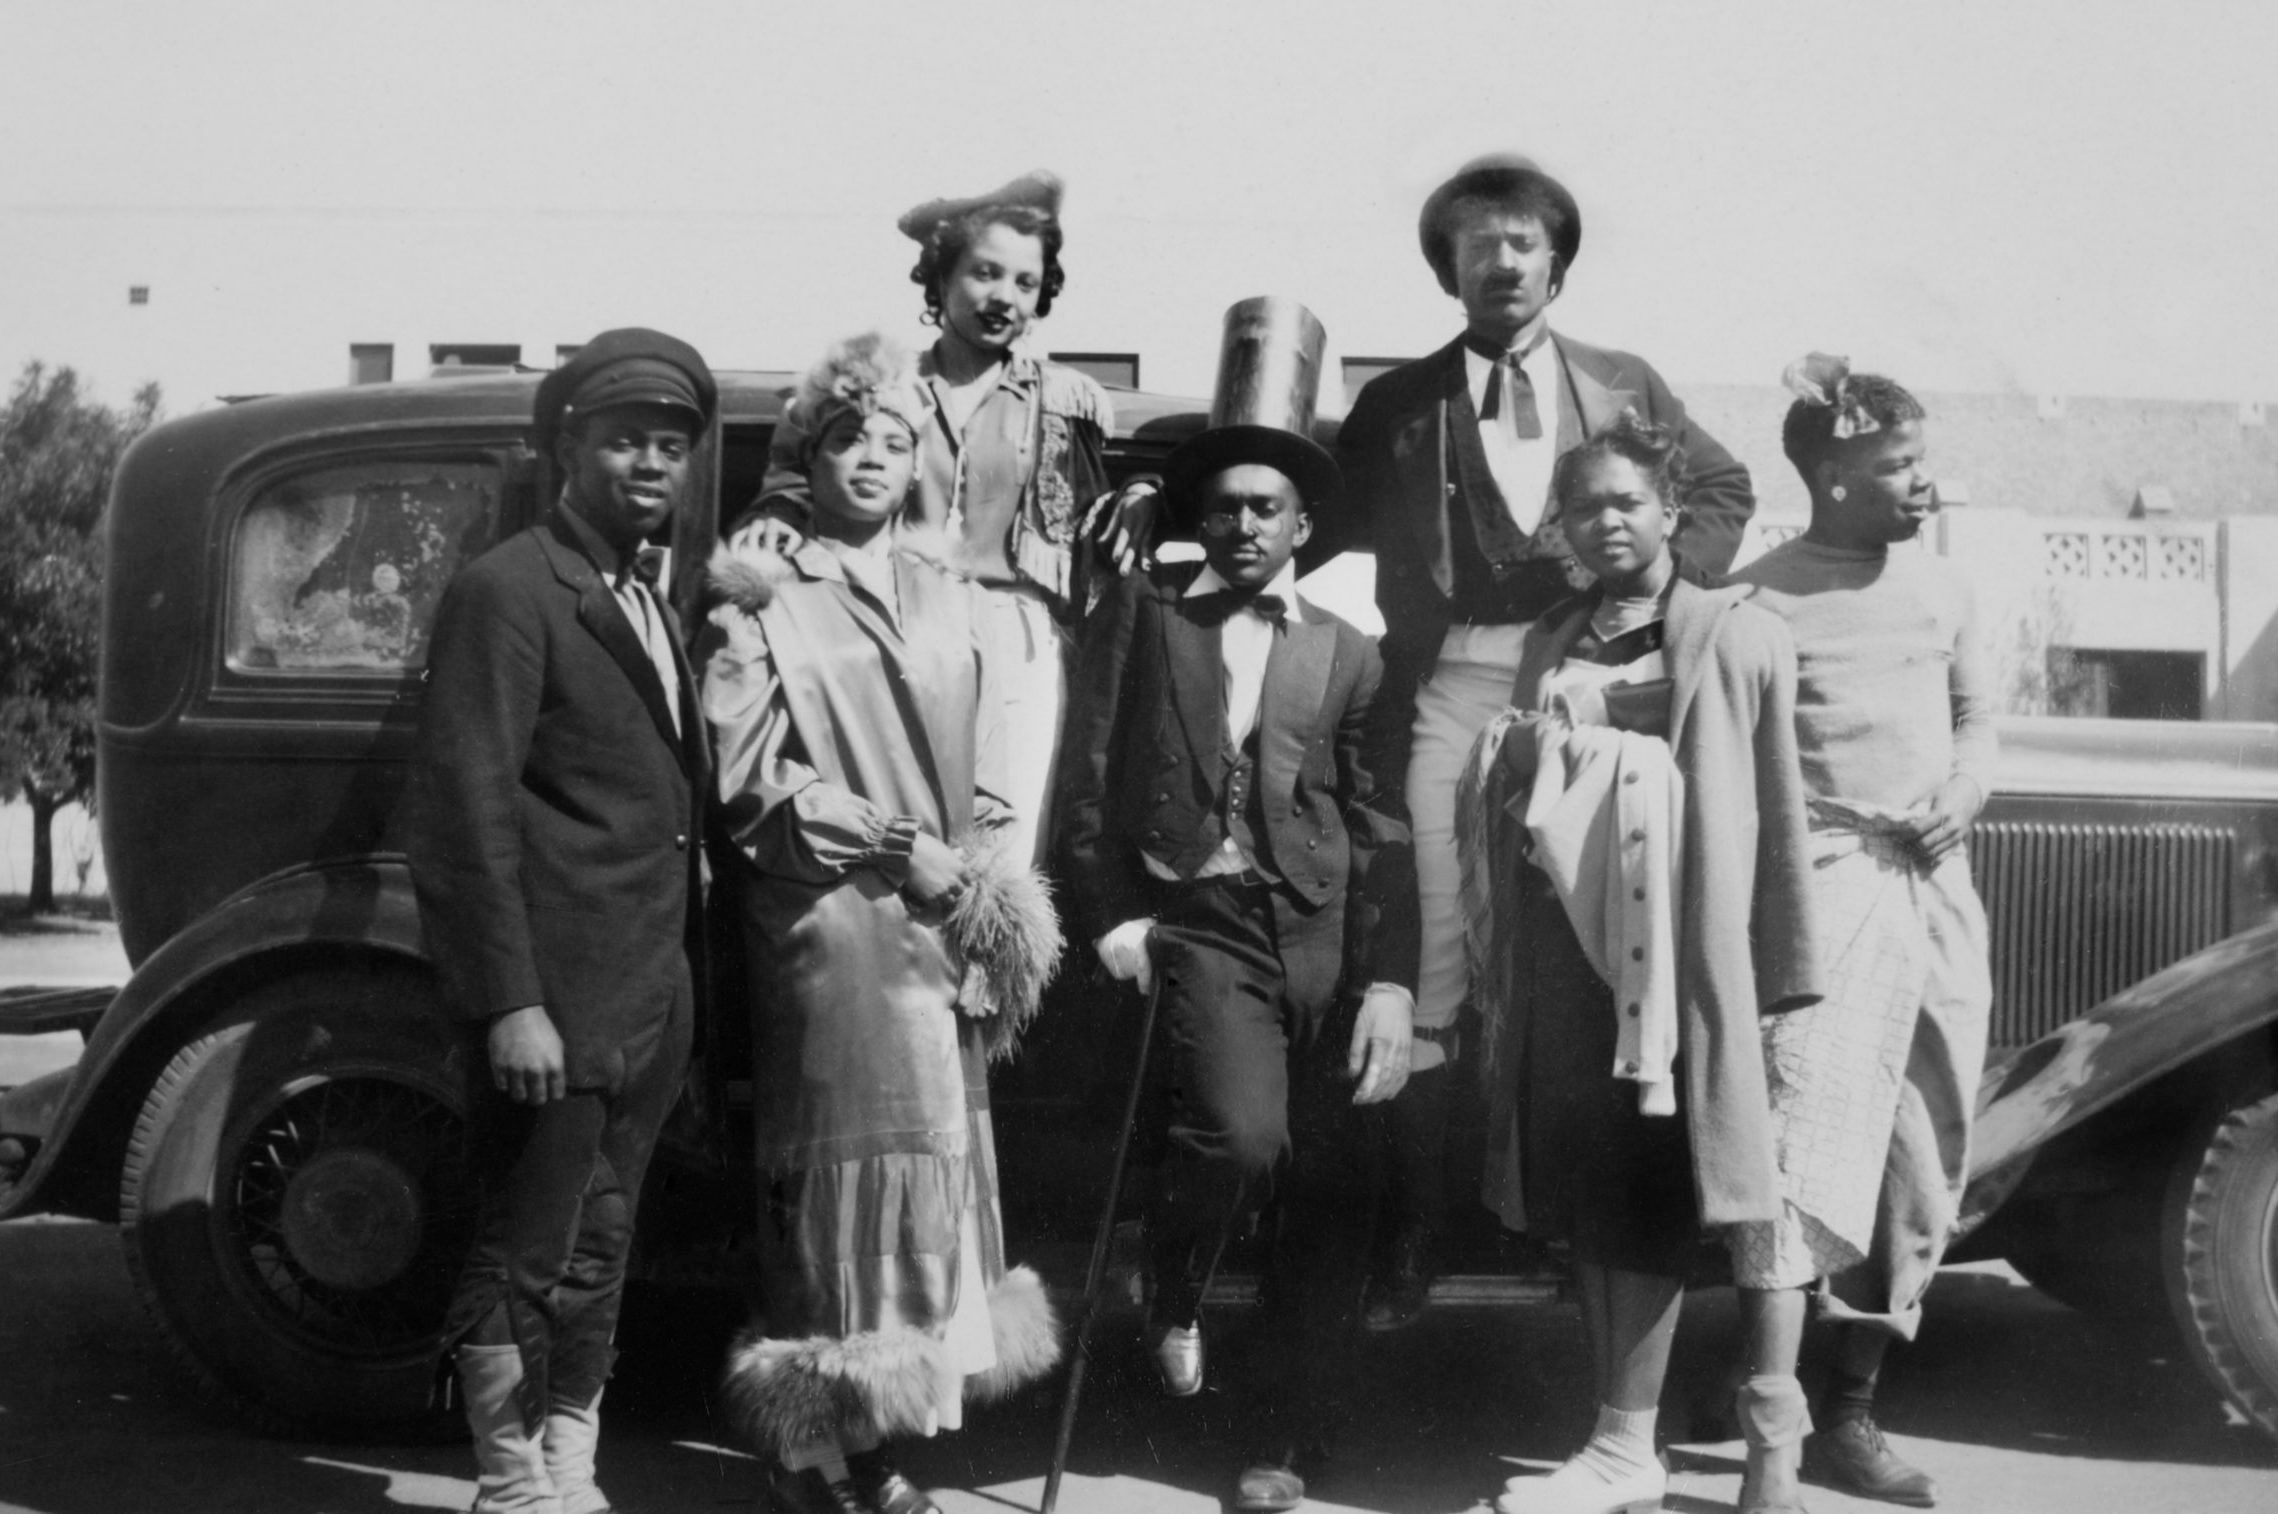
[720,1266,1059,1457]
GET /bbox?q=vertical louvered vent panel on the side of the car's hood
[1970,822,2235,1050]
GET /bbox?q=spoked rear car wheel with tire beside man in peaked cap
[118,963,474,1439]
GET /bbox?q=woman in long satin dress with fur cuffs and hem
[699,335,1059,1514]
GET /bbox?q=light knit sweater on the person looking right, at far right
[1734,537,1993,811]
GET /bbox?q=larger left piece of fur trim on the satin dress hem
[720,1327,948,1457]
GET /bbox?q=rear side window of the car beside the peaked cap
[226,458,501,678]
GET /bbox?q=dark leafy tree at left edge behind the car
[0,362,159,913]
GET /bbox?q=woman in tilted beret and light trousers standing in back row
[738,171,1157,858]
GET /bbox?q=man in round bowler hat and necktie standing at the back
[1337,155,1754,1325]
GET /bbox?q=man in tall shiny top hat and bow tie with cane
[1059,301,1412,1509]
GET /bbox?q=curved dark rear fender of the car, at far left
[0,856,428,1220]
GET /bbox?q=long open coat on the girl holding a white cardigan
[1488,581,1820,1225]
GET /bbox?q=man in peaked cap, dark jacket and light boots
[405,328,718,1514]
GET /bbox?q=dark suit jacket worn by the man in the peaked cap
[408,512,706,1088]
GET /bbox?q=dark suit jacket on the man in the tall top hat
[1057,562,1415,988]
